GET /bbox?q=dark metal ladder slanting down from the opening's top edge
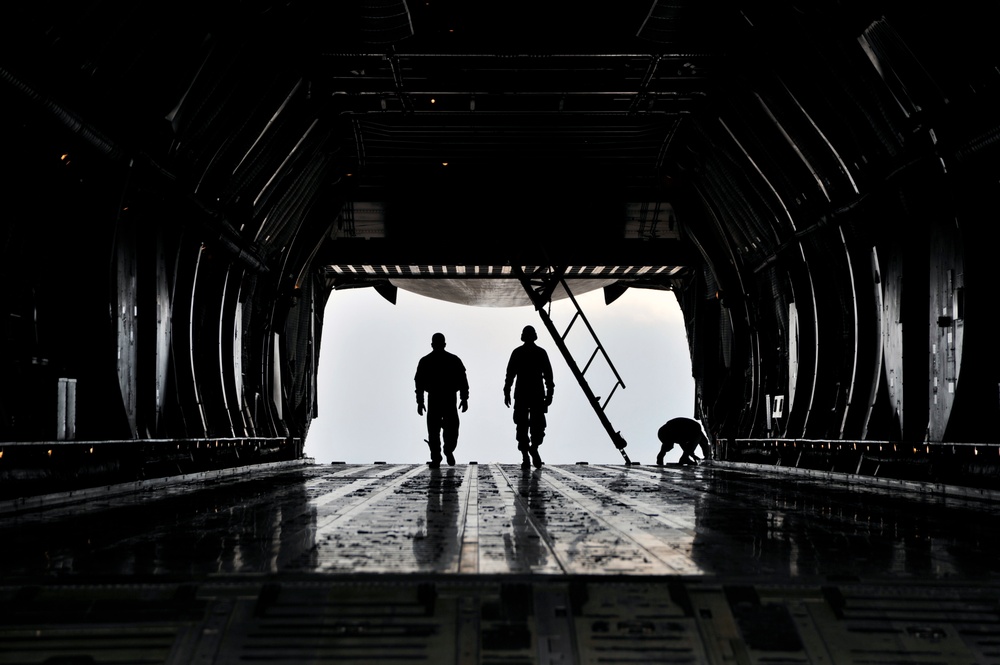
[513,265,632,464]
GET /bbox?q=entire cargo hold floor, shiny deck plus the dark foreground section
[0,464,1000,663]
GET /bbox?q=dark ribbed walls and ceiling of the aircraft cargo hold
[0,0,1000,483]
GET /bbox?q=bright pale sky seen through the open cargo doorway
[305,282,694,465]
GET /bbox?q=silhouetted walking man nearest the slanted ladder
[503,326,554,468]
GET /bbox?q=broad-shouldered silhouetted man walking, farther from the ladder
[413,333,469,469]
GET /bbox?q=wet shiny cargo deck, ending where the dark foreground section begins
[0,464,1000,580]
